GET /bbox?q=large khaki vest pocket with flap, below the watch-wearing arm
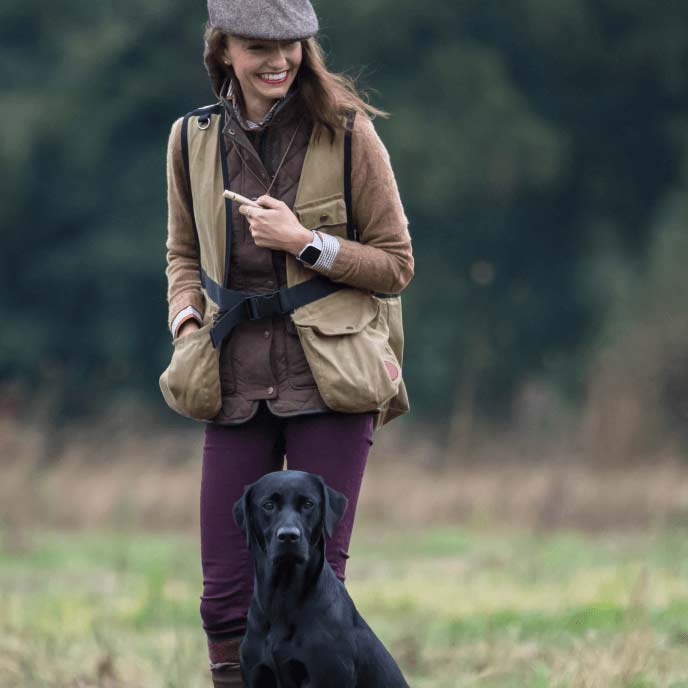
[292,289,401,413]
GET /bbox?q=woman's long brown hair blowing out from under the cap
[203,22,389,140]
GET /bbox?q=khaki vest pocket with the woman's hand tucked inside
[160,323,222,420]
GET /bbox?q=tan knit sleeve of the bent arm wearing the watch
[308,114,414,294]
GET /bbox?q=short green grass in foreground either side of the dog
[0,524,688,688]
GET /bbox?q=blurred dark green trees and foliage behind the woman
[0,0,688,451]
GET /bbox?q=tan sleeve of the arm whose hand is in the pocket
[165,117,205,336]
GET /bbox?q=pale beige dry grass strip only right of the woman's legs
[362,459,688,531]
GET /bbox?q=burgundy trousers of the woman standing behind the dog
[200,403,374,644]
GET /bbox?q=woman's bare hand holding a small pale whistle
[239,196,313,255]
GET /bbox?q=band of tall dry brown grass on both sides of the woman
[0,412,688,546]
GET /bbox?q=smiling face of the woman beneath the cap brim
[224,36,302,111]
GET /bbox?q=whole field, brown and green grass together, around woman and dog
[0,408,688,688]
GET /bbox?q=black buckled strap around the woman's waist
[201,268,345,349]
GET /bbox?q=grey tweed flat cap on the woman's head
[208,0,318,41]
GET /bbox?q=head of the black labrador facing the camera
[234,471,347,563]
